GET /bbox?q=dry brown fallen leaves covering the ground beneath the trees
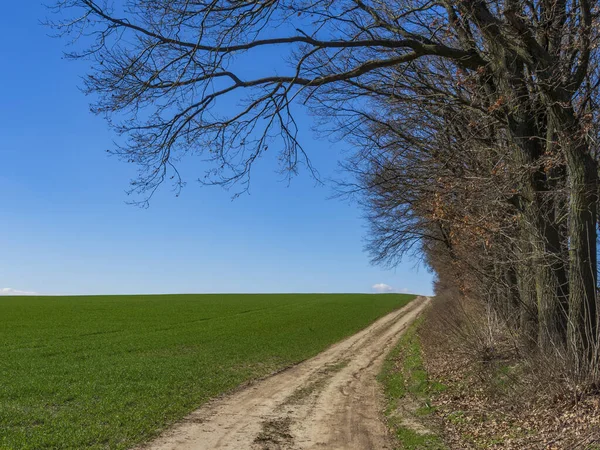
[421,312,600,450]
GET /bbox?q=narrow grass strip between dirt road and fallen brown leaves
[378,317,446,450]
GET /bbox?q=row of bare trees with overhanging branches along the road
[52,0,600,369]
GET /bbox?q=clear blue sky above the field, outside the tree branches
[0,5,432,294]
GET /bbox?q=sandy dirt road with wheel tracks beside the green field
[144,297,428,450]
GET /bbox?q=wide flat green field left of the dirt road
[0,294,413,449]
